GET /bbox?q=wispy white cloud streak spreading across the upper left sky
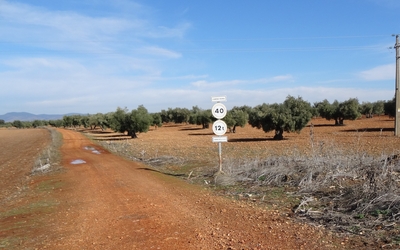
[0,0,191,54]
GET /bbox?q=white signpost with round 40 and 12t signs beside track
[211,96,228,172]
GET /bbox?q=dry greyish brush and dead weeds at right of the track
[216,139,400,246]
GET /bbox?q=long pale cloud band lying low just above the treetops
[8,84,393,113]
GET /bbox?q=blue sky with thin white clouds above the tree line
[0,0,400,114]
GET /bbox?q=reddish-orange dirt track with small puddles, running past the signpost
[18,130,352,249]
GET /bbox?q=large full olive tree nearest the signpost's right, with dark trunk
[249,96,312,140]
